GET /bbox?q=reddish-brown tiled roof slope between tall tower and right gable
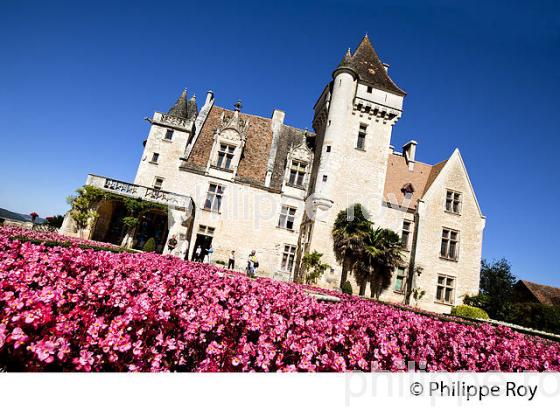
[383,154,447,209]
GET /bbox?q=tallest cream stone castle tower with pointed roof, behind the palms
[301,35,406,285]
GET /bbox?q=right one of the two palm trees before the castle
[355,228,403,298]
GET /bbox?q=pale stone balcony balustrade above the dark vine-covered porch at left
[86,174,192,208]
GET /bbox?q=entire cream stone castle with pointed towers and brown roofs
[62,36,485,312]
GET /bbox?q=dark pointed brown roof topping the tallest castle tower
[339,34,406,96]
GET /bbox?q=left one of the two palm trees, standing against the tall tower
[332,204,371,287]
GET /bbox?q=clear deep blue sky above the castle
[0,0,560,286]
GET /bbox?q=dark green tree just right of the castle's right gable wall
[480,258,517,319]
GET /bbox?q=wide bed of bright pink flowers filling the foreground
[0,231,560,372]
